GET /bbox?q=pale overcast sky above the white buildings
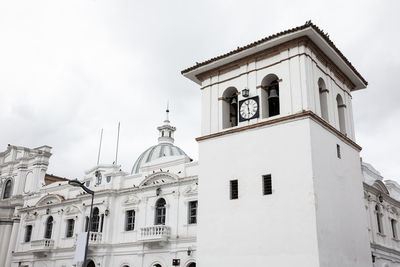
[0,0,400,181]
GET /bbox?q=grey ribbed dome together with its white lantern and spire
[131,107,191,174]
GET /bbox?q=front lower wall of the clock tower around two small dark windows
[198,120,319,267]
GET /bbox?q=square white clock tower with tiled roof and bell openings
[182,22,372,267]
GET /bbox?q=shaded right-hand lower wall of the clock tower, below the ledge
[310,120,371,267]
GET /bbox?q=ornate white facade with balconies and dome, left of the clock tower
[1,115,198,267]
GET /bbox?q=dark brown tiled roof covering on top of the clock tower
[181,20,368,85]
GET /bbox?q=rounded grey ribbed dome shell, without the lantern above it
[131,143,190,174]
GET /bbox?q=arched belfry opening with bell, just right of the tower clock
[261,74,280,118]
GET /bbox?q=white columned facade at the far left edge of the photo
[0,145,51,266]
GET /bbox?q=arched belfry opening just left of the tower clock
[222,87,238,129]
